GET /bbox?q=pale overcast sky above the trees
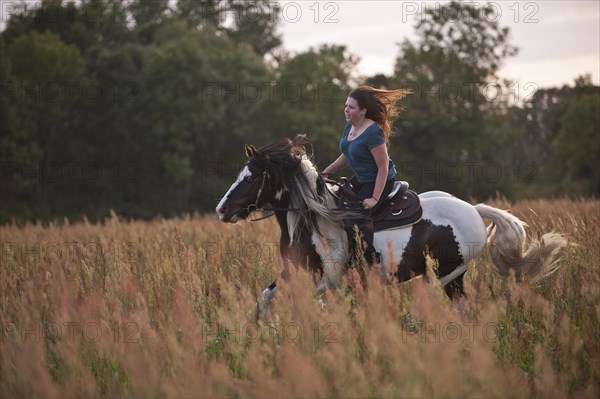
[279,0,600,91]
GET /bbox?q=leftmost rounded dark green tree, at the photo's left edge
[0,32,87,219]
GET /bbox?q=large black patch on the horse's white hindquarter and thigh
[396,219,464,297]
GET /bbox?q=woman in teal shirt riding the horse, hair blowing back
[323,86,411,264]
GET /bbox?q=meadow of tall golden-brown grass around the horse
[0,199,600,398]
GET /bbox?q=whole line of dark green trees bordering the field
[0,0,600,223]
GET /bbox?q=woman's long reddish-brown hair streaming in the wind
[349,86,413,147]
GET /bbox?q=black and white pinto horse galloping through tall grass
[216,136,566,315]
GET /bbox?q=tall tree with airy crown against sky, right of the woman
[390,1,517,197]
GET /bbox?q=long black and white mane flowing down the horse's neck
[254,135,359,242]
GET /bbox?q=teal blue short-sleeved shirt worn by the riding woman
[340,123,396,183]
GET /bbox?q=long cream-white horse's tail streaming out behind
[475,204,567,280]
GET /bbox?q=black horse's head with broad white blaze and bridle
[216,139,299,223]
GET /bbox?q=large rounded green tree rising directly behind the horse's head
[140,21,271,212]
